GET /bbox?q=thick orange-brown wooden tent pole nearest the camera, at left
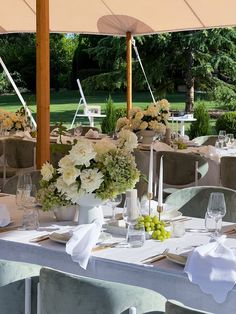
[36,0,50,169]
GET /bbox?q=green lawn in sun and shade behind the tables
[0,90,216,129]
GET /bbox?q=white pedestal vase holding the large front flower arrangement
[78,194,103,225]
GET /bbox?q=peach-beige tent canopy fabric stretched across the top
[0,0,236,36]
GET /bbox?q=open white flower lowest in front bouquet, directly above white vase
[80,169,103,193]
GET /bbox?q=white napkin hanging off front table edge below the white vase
[66,221,102,269]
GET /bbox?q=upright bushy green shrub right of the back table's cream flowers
[189,103,210,139]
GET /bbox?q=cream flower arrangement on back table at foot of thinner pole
[116,99,170,133]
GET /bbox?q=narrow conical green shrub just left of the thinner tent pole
[101,96,116,134]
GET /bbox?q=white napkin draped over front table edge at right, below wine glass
[184,236,236,303]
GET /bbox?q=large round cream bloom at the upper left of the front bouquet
[70,139,96,167]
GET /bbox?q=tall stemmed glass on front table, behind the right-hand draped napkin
[207,192,226,237]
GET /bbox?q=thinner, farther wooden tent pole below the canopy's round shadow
[126,32,132,117]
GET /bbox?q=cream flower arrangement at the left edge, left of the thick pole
[0,107,30,131]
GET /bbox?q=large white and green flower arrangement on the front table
[38,130,139,211]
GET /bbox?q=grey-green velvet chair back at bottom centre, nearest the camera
[40,268,166,314]
